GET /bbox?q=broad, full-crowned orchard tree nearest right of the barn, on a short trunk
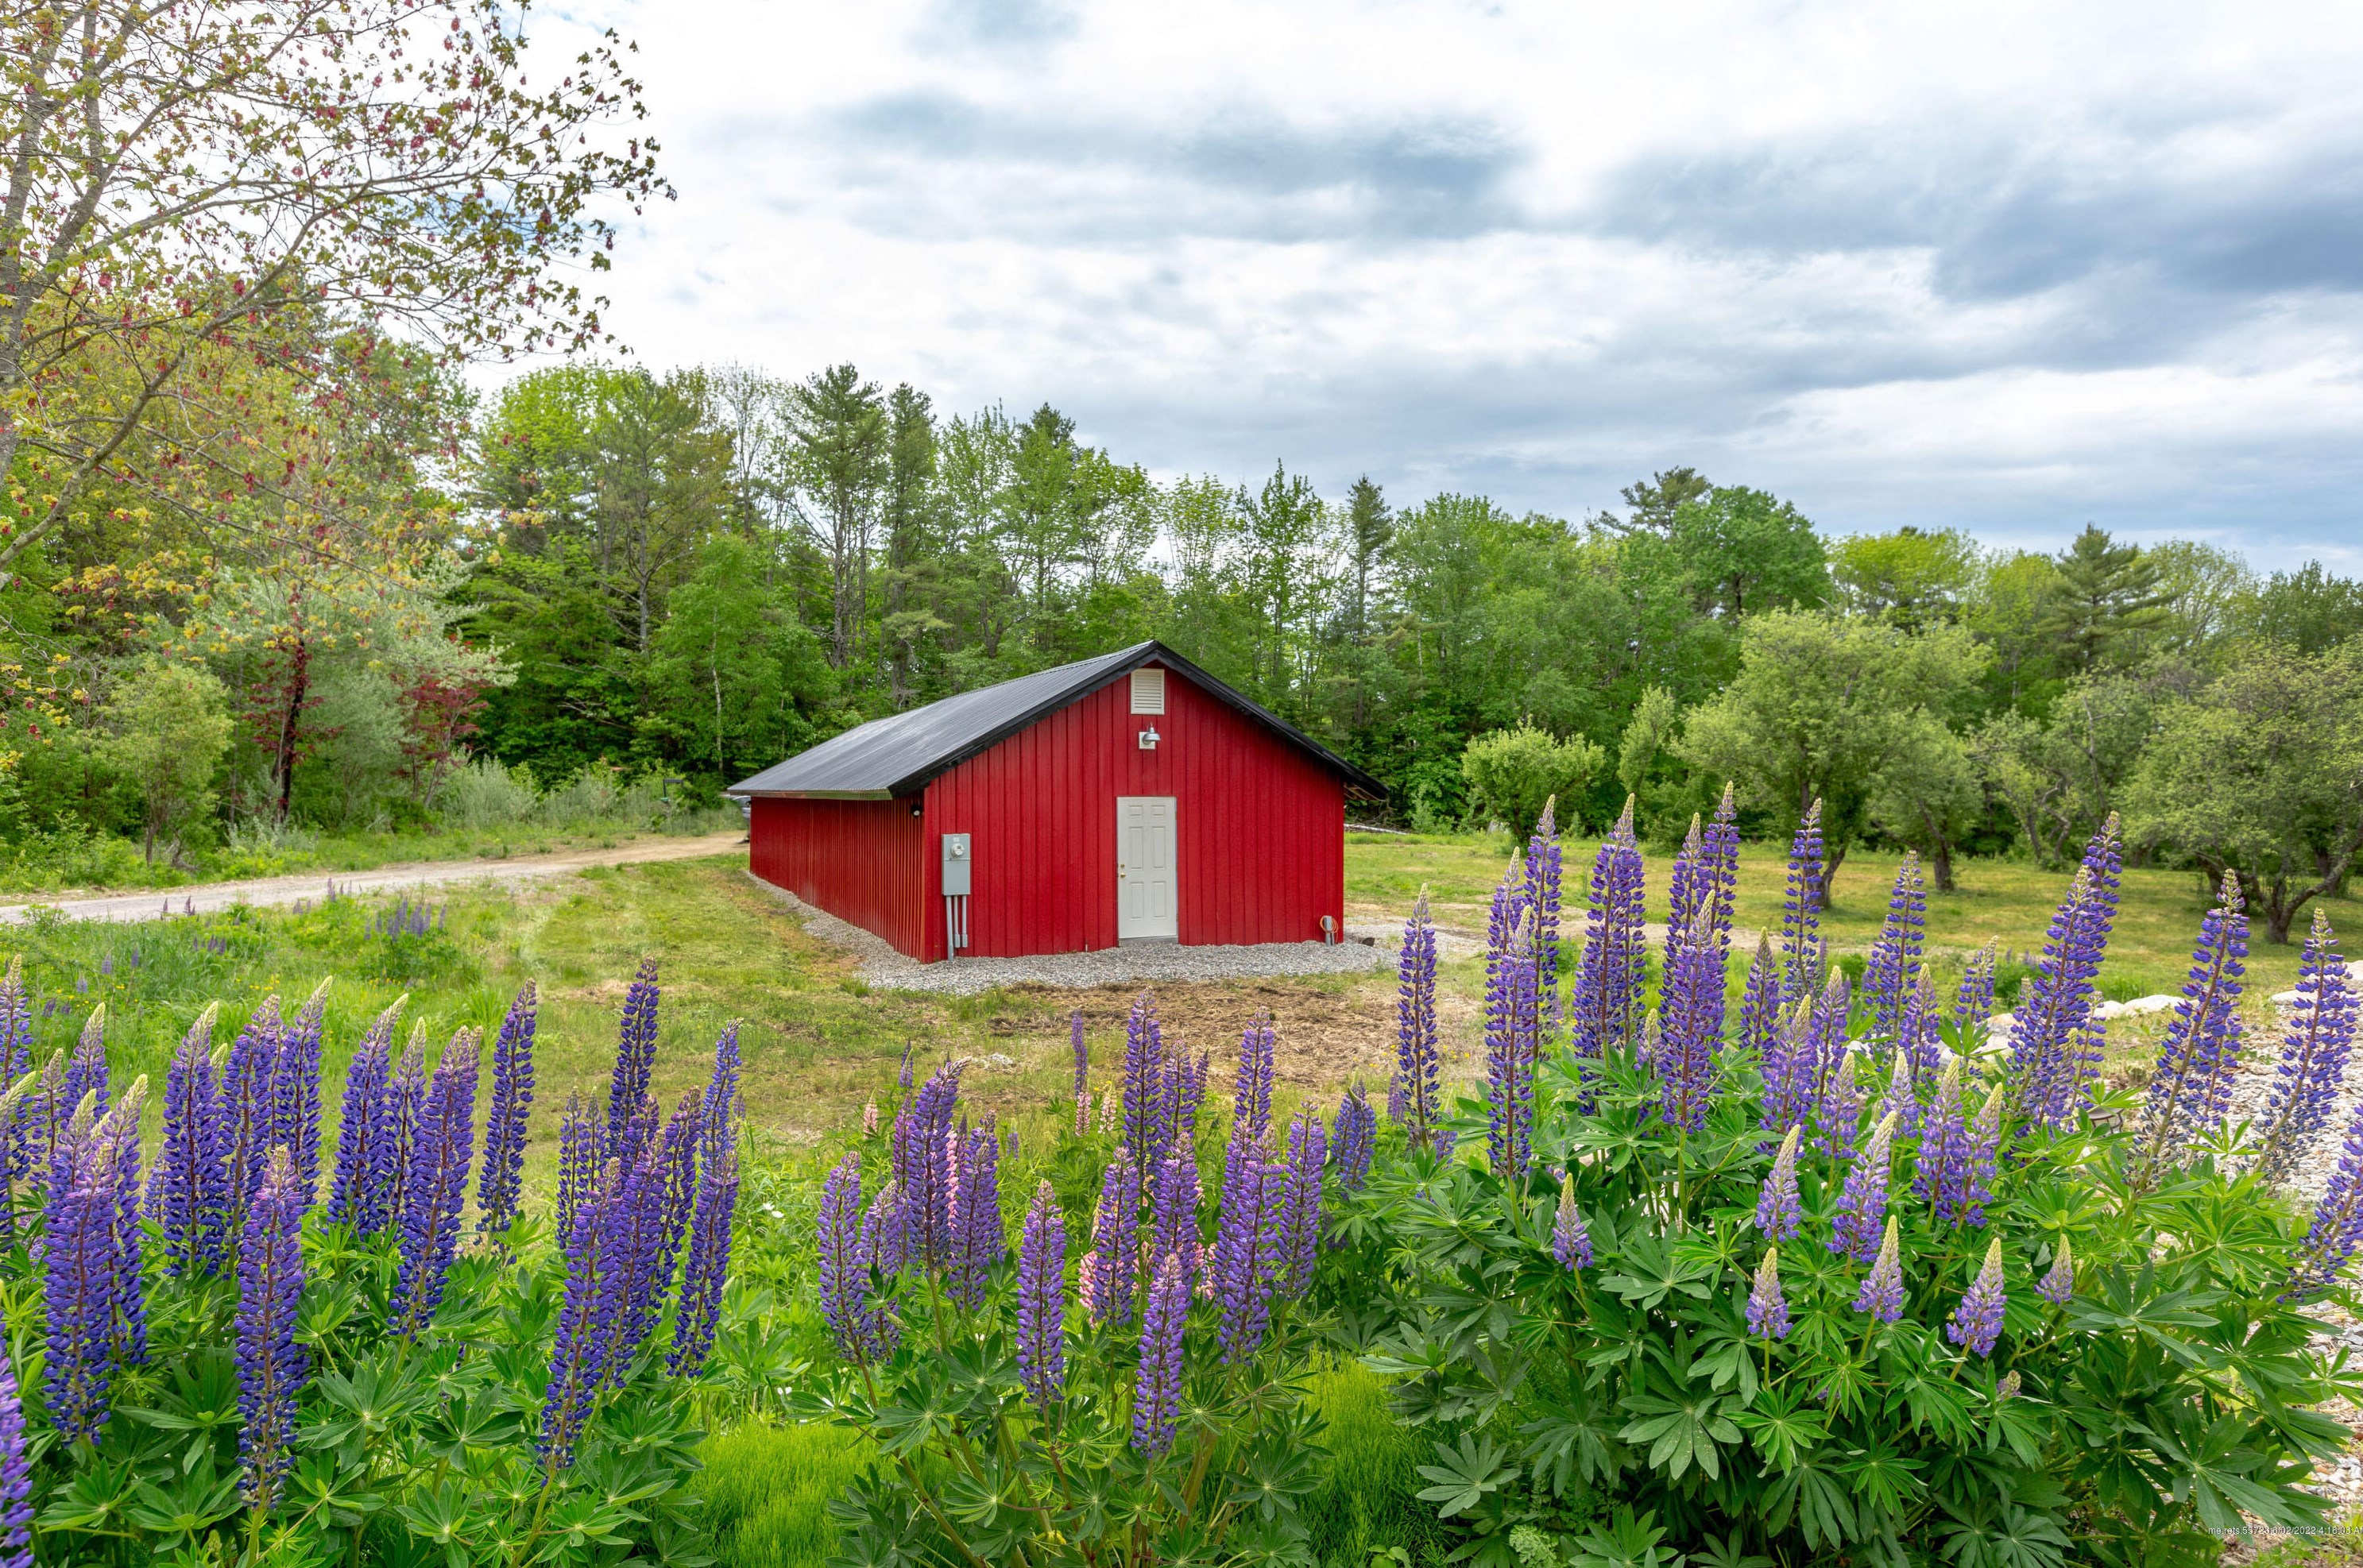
[1676,609,1985,900]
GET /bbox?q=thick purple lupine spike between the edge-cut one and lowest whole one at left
[43,1129,123,1445]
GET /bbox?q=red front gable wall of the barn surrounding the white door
[907,673,1344,961]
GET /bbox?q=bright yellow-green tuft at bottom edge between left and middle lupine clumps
[697,1422,884,1568]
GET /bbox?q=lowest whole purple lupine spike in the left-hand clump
[238,1148,312,1514]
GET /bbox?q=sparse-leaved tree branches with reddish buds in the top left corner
[0,0,664,569]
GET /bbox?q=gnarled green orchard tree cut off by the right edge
[2127,643,2363,942]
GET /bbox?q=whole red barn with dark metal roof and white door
[730,643,1383,961]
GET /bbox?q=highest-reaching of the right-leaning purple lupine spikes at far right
[2011,813,2125,1126]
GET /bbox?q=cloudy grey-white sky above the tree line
[536,0,2363,571]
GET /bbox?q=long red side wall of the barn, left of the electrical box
[747,798,921,959]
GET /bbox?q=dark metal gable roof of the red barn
[728,643,1387,801]
